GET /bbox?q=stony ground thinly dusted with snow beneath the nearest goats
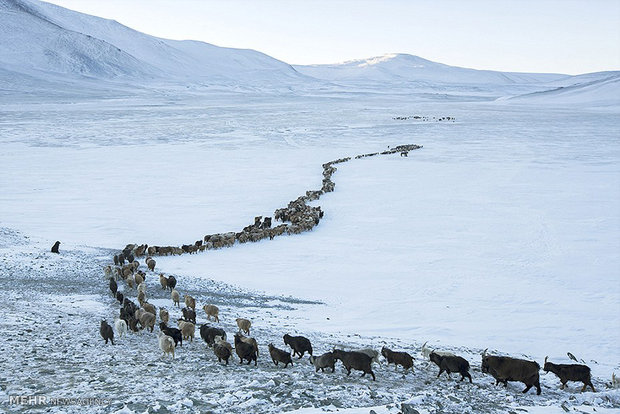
[0,229,620,413]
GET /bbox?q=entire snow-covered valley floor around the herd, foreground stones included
[0,91,620,412]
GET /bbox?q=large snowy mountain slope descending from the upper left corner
[0,0,306,84]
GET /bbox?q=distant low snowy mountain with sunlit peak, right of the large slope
[295,54,568,85]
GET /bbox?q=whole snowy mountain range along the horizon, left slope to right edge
[0,0,620,105]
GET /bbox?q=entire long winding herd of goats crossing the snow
[100,145,612,394]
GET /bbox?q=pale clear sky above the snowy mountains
[44,0,620,74]
